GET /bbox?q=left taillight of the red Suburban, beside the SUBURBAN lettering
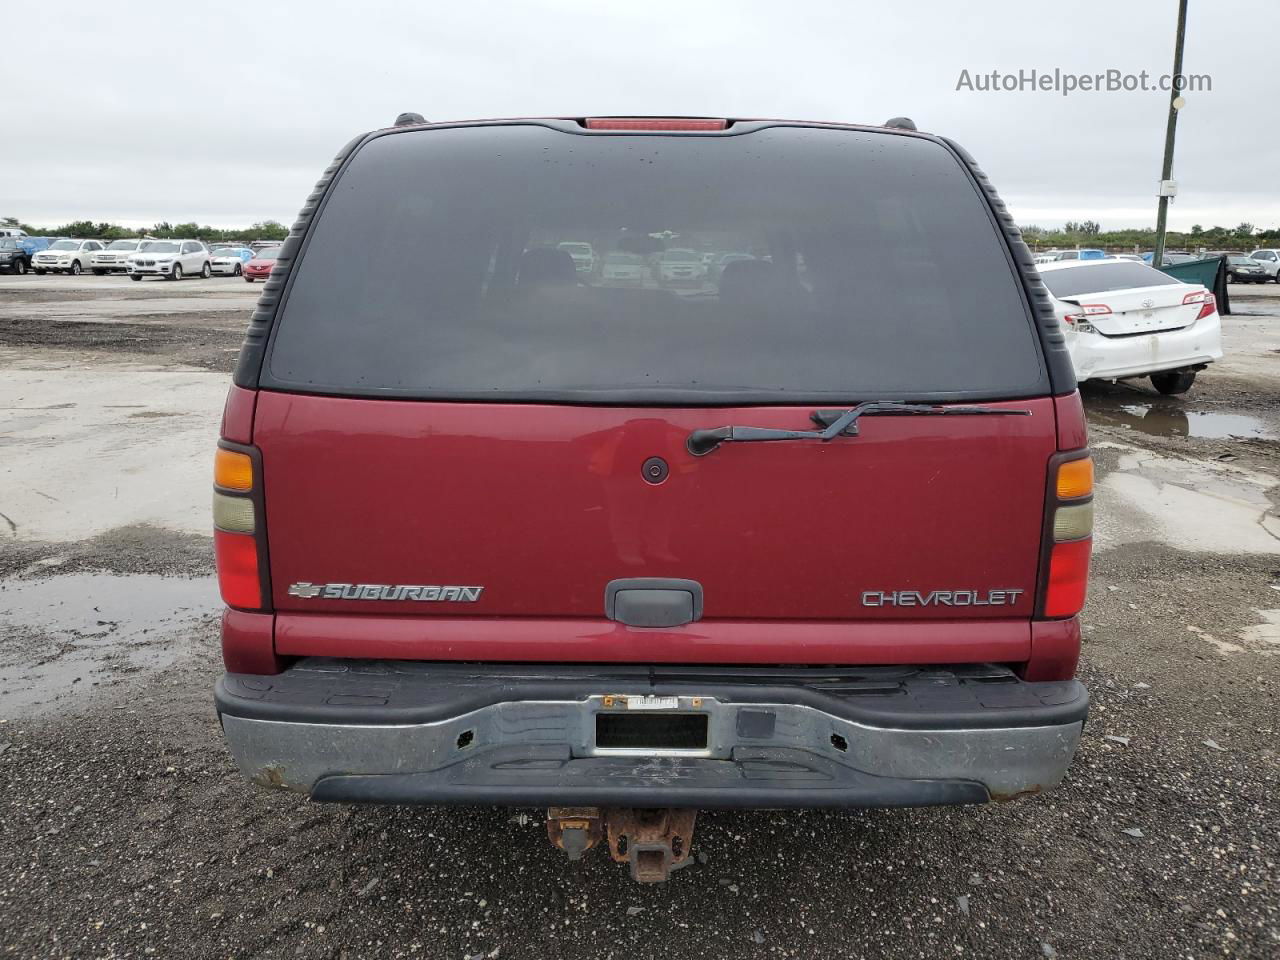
[214,440,271,611]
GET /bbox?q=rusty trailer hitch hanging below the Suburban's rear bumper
[547,806,698,883]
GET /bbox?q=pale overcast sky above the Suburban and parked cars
[0,0,1280,229]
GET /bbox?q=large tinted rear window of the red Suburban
[259,124,1047,403]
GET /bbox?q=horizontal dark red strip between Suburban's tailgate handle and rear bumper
[275,613,1029,664]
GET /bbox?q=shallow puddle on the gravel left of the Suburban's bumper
[0,573,221,718]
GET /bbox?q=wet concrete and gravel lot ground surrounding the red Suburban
[0,276,1280,959]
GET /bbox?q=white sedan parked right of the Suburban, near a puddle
[1038,260,1222,394]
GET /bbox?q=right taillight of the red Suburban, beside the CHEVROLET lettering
[1039,451,1093,617]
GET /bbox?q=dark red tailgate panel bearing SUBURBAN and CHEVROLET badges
[253,392,1055,625]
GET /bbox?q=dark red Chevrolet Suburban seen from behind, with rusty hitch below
[214,114,1093,881]
